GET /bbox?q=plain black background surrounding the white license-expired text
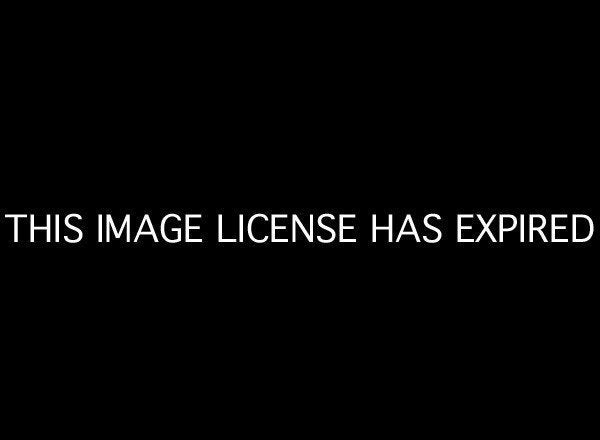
[1,5,598,433]
